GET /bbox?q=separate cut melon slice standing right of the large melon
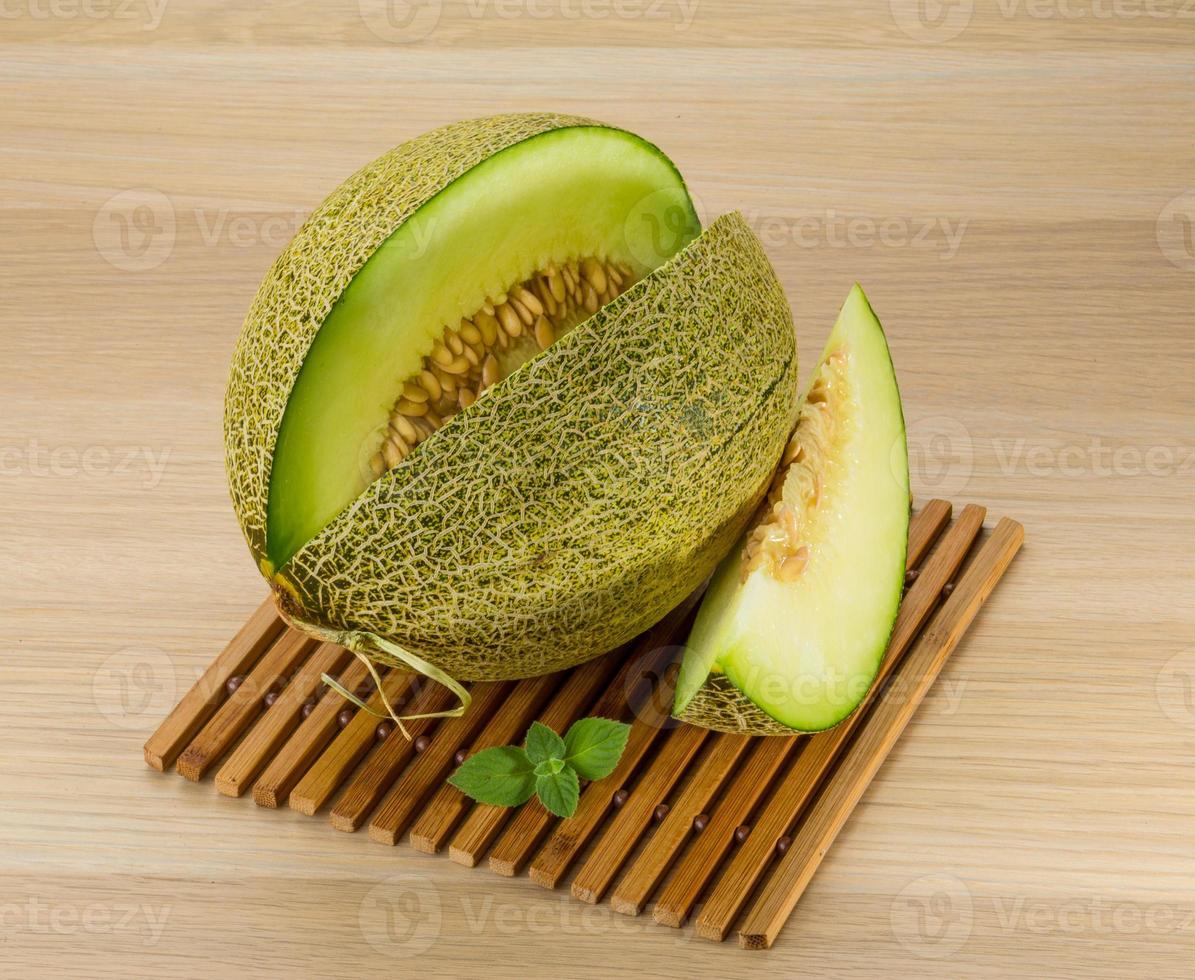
[674,286,909,734]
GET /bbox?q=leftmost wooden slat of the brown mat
[145,598,283,772]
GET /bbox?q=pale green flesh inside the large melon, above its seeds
[265,125,700,571]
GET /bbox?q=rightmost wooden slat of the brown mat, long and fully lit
[739,519,1024,949]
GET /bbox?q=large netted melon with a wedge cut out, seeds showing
[225,114,796,680]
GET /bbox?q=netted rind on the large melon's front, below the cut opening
[286,215,797,680]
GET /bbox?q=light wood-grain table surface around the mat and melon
[0,0,1195,980]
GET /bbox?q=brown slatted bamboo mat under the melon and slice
[145,500,1024,949]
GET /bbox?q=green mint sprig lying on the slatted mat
[448,718,631,816]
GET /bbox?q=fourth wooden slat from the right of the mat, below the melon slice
[609,733,752,915]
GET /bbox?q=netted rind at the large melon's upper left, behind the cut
[225,112,602,563]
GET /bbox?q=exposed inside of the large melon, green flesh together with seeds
[265,118,700,568]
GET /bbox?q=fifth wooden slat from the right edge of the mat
[572,724,710,905]
